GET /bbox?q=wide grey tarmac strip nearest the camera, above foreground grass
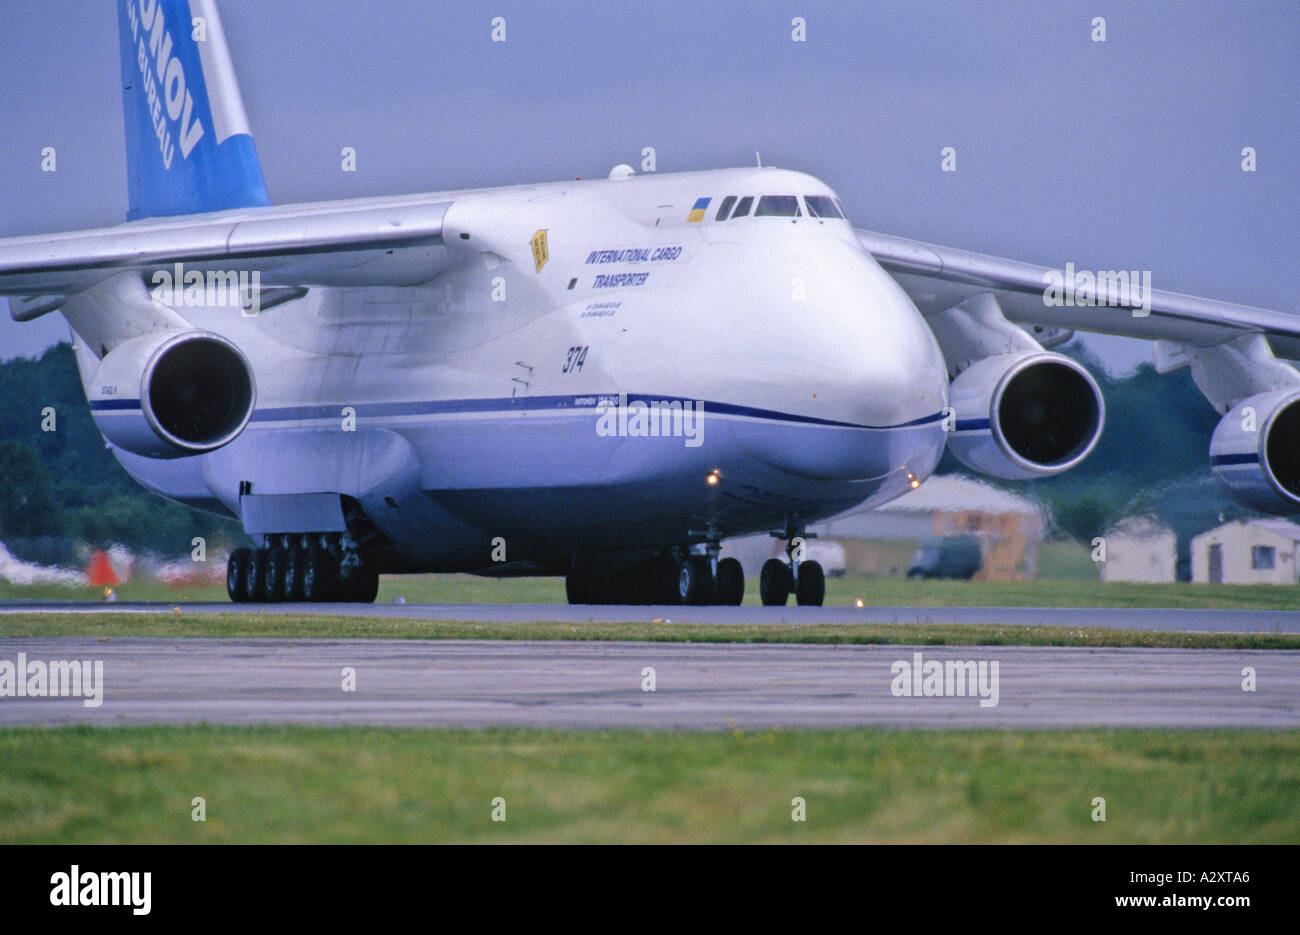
[0,637,1300,730]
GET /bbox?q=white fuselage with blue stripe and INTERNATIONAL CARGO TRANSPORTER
[82,169,948,571]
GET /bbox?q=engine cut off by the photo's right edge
[1210,389,1300,514]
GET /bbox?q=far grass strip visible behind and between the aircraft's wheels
[0,575,1300,610]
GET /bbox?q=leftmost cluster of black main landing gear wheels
[226,545,380,603]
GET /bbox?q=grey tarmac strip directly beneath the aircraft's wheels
[0,601,1300,633]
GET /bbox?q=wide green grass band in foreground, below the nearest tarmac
[0,726,1300,844]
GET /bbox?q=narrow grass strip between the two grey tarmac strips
[0,606,1300,649]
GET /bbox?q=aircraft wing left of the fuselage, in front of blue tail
[0,195,451,321]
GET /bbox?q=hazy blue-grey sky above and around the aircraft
[0,0,1300,369]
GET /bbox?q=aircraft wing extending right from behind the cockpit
[855,229,1300,359]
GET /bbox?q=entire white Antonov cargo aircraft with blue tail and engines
[0,0,1300,605]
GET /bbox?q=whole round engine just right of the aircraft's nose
[948,351,1105,480]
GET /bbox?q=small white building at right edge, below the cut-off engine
[1192,519,1300,584]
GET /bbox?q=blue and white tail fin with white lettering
[117,0,270,221]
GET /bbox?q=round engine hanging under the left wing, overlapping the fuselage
[86,330,256,458]
